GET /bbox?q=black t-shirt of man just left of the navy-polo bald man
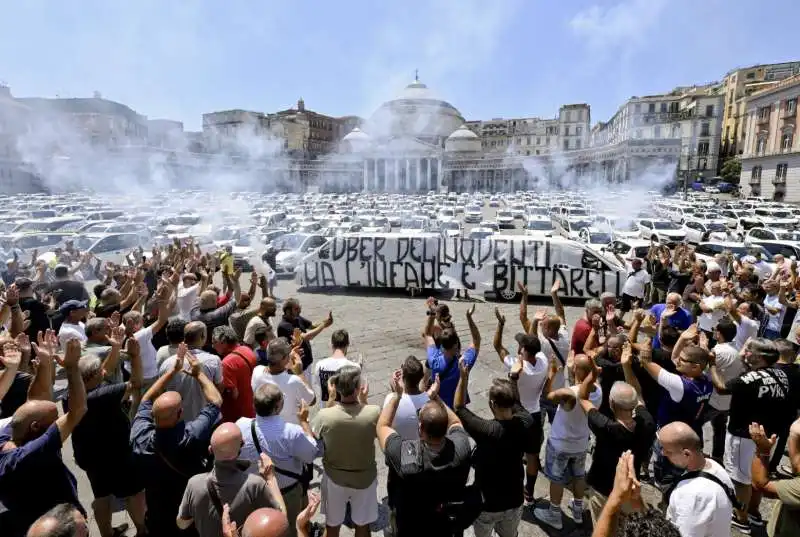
[64,383,131,470]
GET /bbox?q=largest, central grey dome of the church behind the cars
[367,79,464,147]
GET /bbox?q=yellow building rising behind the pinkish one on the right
[720,62,800,158]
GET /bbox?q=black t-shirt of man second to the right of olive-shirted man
[456,407,537,513]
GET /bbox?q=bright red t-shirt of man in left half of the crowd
[222,345,256,422]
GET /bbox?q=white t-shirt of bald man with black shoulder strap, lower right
[666,459,733,537]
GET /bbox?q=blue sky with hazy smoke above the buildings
[0,0,800,130]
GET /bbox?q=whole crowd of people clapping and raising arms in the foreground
[0,243,800,537]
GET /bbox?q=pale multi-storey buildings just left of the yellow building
[589,86,723,182]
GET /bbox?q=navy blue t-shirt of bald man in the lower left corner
[0,423,86,537]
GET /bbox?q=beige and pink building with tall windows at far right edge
[739,75,800,203]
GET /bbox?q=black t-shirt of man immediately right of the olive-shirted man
[385,427,472,536]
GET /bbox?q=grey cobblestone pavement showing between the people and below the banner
[69,275,768,537]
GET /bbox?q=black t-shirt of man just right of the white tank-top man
[586,405,656,496]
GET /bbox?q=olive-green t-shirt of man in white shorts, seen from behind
[313,403,381,489]
